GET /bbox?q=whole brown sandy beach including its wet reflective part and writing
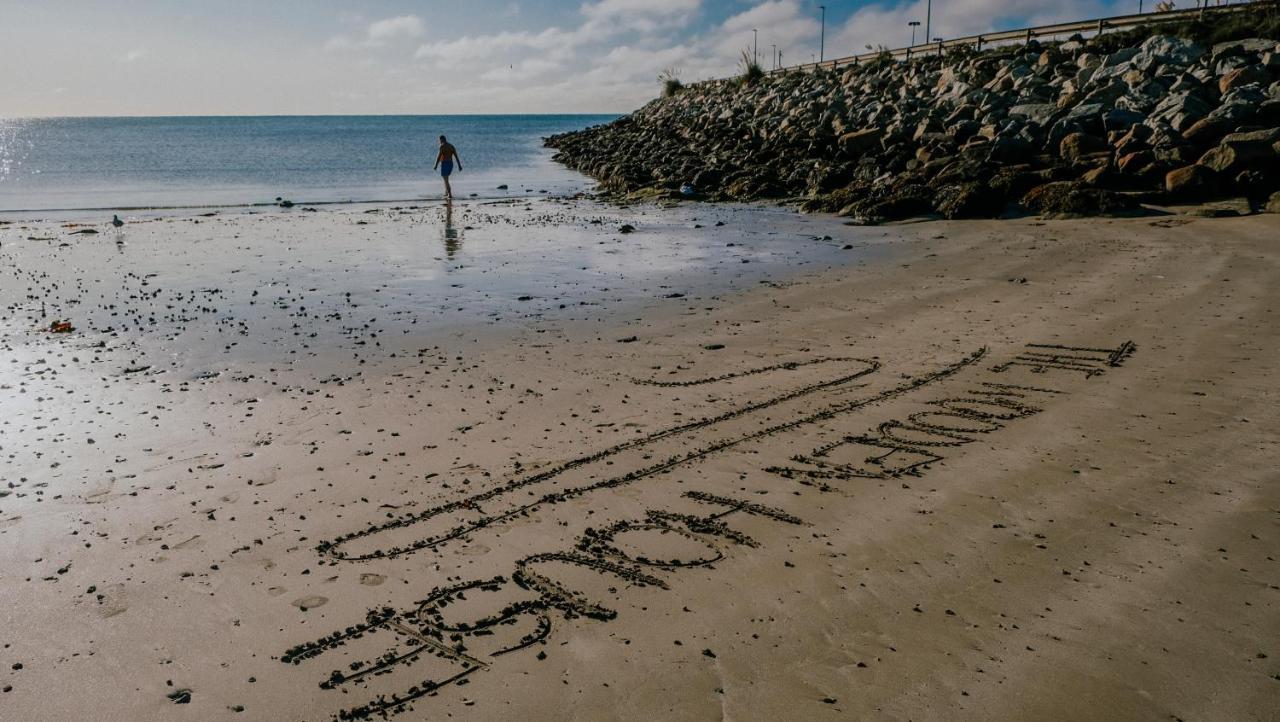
[0,200,1280,719]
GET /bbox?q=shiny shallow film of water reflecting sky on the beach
[0,198,874,379]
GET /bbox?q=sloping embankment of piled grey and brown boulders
[547,28,1280,221]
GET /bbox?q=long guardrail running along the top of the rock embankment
[768,0,1280,74]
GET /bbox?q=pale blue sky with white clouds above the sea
[0,0,1131,118]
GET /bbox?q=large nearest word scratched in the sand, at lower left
[282,492,804,719]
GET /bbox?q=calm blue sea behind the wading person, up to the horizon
[0,115,614,213]
